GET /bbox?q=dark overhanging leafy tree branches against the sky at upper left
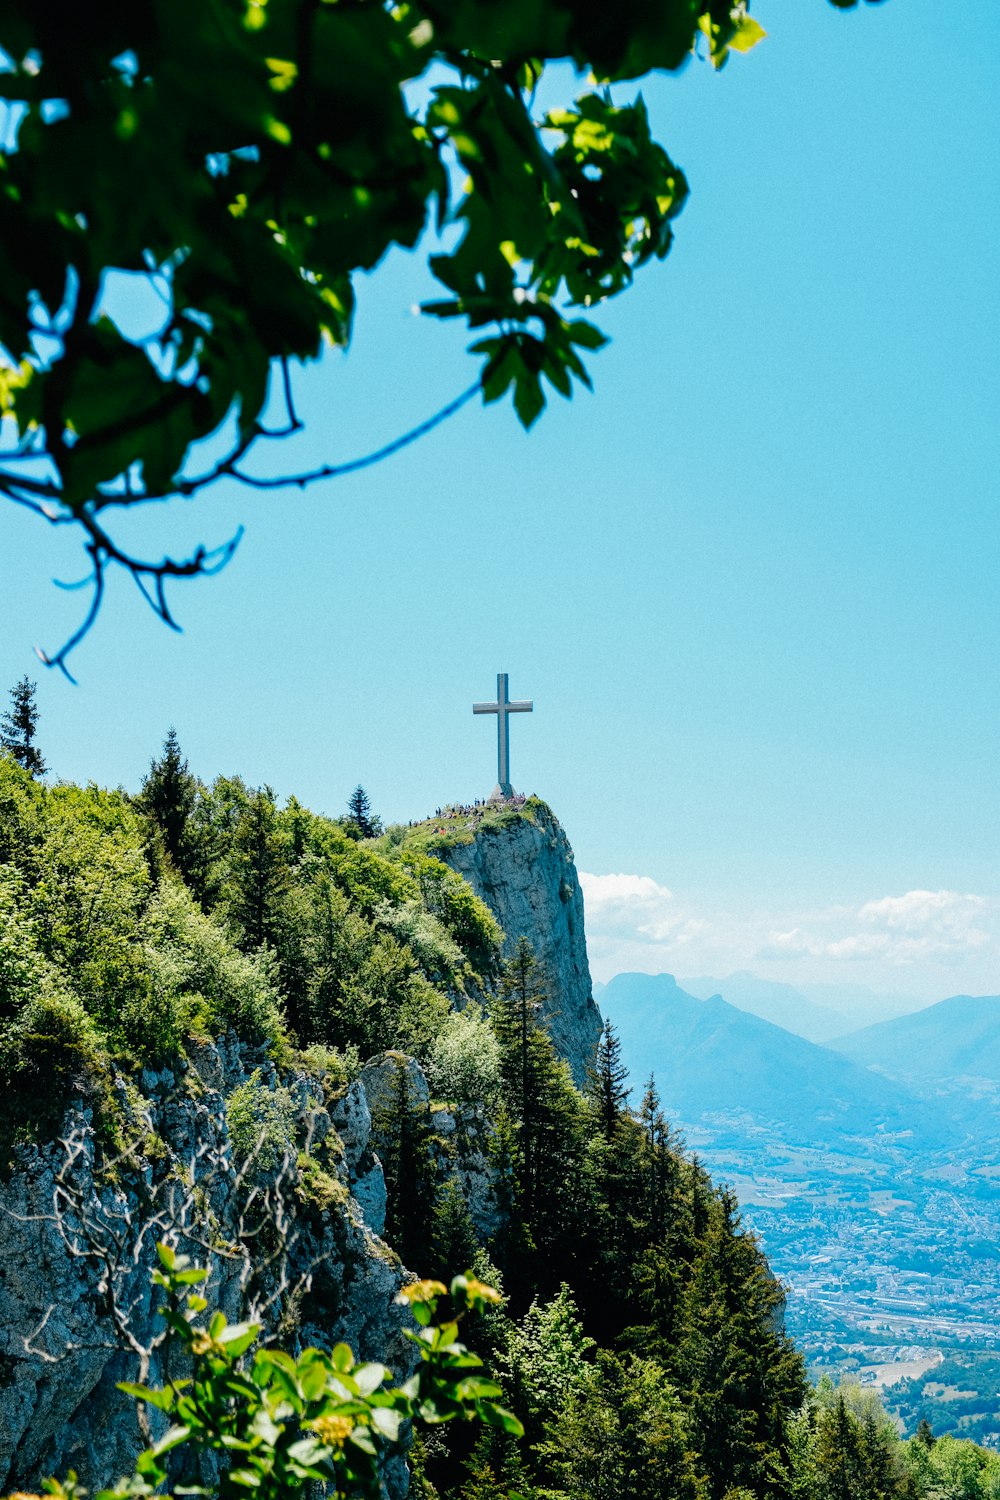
[0,0,881,666]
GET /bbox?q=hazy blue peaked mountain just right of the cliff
[601,974,928,1145]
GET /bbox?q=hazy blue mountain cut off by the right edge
[831,995,1000,1085]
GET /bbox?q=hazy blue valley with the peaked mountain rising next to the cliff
[601,975,1000,1448]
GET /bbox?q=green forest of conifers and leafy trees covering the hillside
[0,720,1000,1500]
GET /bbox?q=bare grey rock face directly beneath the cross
[435,798,601,1085]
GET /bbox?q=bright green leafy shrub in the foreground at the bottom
[35,1244,520,1500]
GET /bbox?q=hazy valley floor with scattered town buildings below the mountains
[685,1116,1000,1446]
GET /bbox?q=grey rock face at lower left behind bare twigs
[0,1038,412,1496]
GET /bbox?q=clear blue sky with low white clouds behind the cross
[0,0,1000,999]
